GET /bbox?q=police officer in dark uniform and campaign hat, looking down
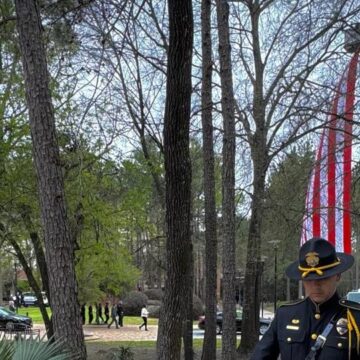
[251,238,360,360]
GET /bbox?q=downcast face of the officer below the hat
[303,275,340,304]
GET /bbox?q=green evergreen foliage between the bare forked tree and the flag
[262,149,312,299]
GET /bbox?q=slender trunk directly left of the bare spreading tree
[216,0,236,360]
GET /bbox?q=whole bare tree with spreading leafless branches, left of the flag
[222,0,360,354]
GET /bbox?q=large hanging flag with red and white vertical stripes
[301,52,359,254]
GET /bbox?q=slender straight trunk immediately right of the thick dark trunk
[201,0,217,360]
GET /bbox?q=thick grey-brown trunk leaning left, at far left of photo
[15,0,86,359]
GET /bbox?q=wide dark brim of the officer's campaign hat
[285,253,354,280]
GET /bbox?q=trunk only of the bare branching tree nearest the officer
[238,7,269,355]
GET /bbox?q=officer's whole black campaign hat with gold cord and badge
[286,238,354,280]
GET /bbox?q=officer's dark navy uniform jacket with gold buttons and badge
[251,294,360,360]
